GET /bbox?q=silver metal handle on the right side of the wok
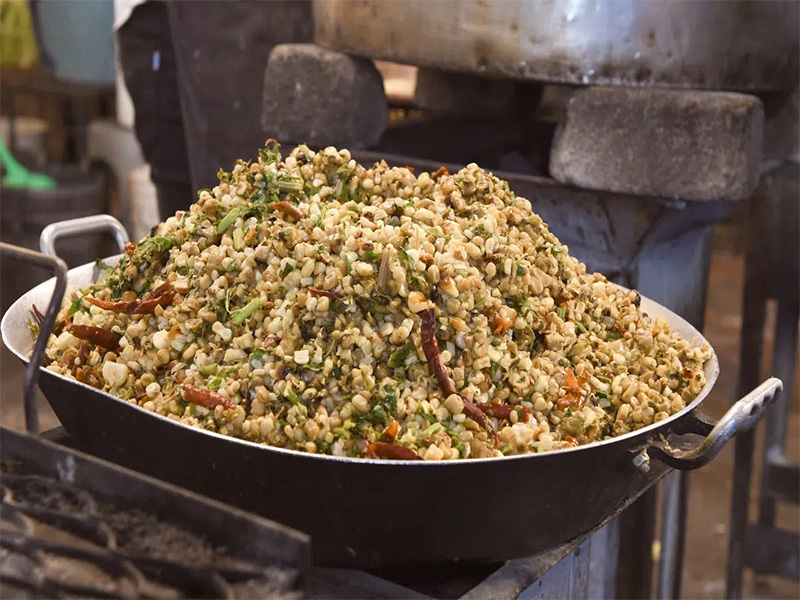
[634,377,783,471]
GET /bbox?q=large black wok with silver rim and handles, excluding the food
[2,217,782,568]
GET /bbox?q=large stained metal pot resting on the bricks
[314,0,800,91]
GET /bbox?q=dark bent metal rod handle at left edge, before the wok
[0,242,67,433]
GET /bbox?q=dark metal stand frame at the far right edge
[726,165,800,599]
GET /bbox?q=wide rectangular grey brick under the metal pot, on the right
[550,87,764,200]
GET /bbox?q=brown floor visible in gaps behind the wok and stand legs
[0,230,800,599]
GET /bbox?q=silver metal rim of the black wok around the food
[0,254,719,469]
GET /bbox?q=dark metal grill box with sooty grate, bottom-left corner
[0,429,308,598]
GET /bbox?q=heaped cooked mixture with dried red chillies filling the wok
[40,142,711,460]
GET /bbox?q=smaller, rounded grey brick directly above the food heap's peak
[261,44,388,149]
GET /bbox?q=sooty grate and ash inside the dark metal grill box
[0,469,300,598]
